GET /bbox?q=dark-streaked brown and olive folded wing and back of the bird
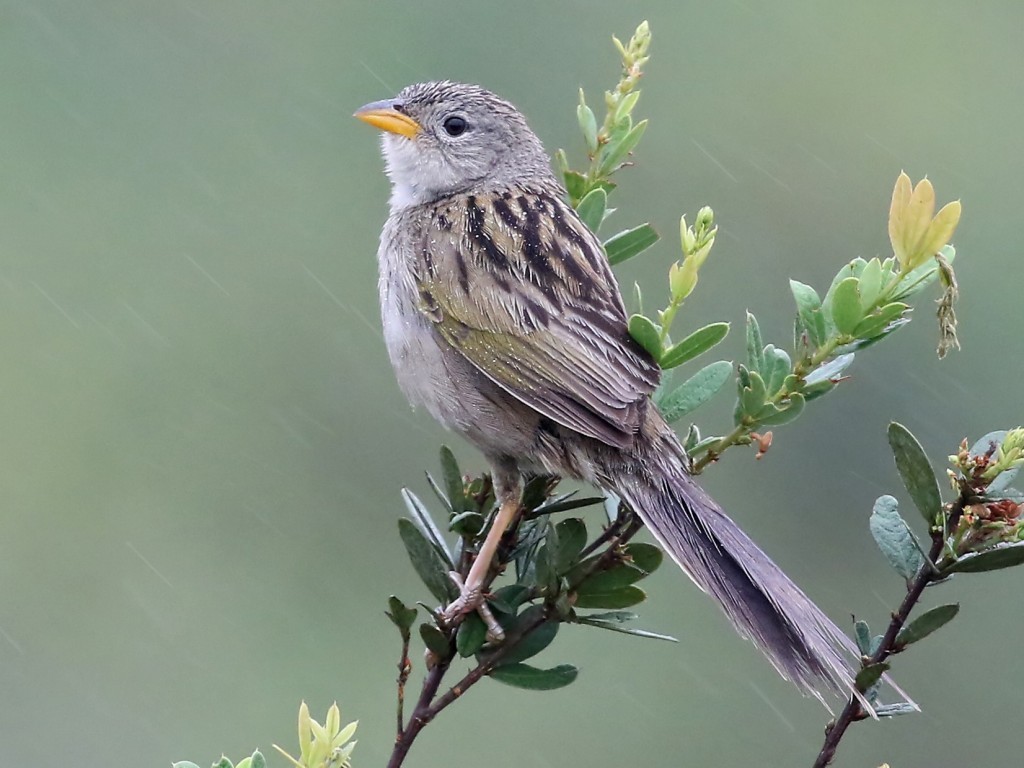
[415,189,660,446]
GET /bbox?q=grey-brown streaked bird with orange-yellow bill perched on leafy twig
[355,80,870,711]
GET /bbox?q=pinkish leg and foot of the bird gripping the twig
[441,462,522,641]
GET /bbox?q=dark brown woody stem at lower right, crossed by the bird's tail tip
[813,485,974,768]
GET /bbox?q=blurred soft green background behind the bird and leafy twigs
[0,0,1024,768]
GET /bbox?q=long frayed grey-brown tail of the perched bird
[608,439,870,711]
